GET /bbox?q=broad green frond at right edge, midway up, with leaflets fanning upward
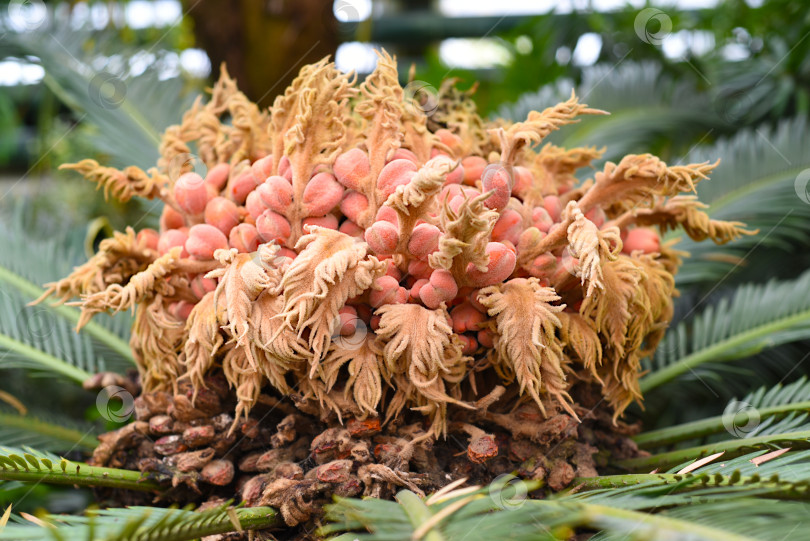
[640,271,810,393]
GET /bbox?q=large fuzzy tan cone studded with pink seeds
[38,53,751,438]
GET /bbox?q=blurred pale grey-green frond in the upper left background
[4,24,196,168]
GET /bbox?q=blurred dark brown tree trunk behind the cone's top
[183,0,338,106]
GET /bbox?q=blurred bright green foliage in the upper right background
[417,0,810,127]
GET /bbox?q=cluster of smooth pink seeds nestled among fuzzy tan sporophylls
[138,130,660,353]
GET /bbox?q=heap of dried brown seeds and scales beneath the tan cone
[91,371,640,539]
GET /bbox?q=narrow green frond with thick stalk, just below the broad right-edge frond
[633,377,810,449]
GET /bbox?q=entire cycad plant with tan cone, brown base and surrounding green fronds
[0,48,810,540]
